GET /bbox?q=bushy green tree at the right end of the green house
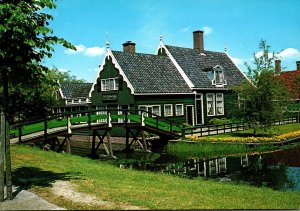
[235,40,289,134]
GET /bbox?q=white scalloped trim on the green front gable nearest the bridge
[89,48,134,97]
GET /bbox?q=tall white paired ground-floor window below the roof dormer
[206,93,224,116]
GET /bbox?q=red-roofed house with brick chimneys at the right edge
[275,60,300,102]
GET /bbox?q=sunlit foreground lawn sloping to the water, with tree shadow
[11,145,300,209]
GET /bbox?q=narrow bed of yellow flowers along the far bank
[187,130,300,143]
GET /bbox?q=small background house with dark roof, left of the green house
[56,83,93,113]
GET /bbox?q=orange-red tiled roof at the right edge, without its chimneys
[279,70,300,99]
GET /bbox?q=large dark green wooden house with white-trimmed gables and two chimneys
[89,31,246,125]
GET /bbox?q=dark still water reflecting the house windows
[115,145,300,191]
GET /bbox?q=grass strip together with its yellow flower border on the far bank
[187,123,300,143]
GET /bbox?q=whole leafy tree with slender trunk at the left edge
[0,0,76,201]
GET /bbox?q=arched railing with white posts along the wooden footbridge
[10,109,182,141]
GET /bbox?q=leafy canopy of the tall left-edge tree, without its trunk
[0,0,76,120]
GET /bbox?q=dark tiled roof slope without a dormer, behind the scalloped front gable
[112,51,192,93]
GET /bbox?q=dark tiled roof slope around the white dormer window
[166,45,246,88]
